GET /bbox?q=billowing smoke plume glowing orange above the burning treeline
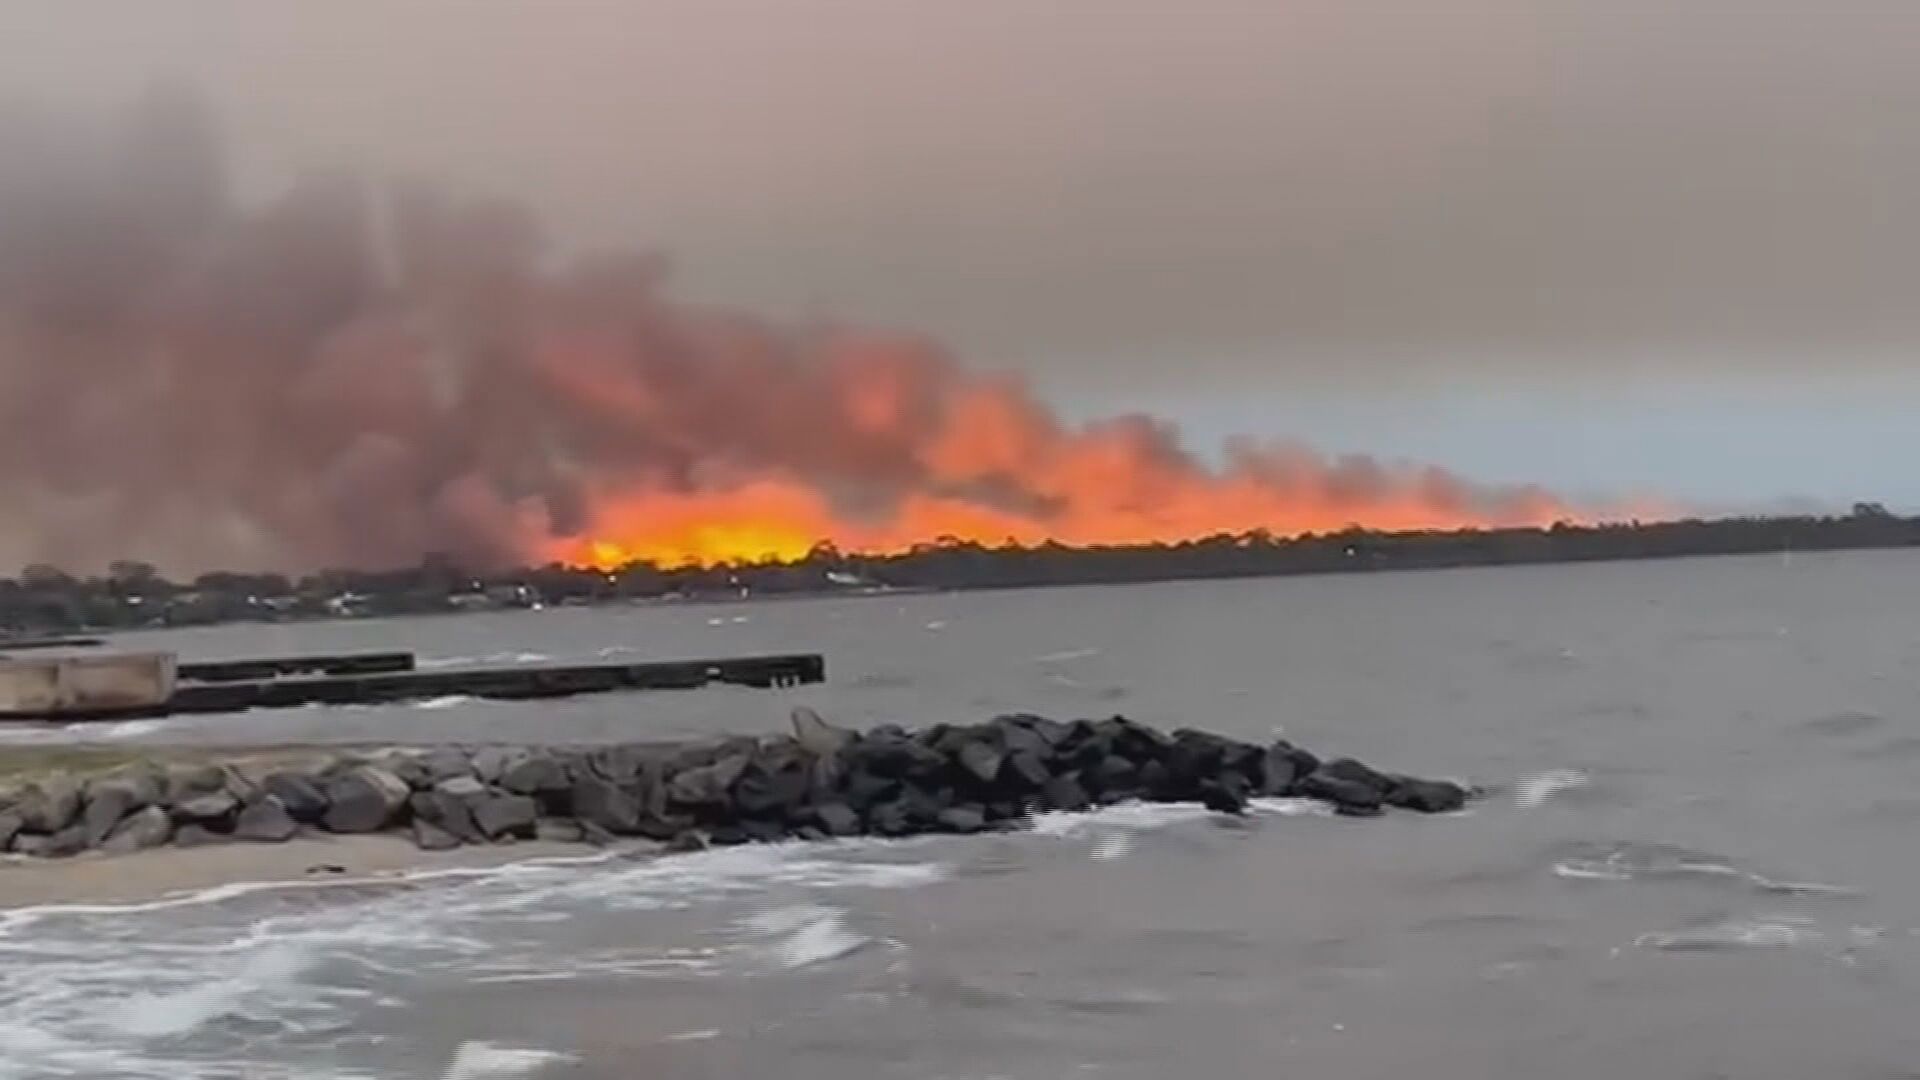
[0,92,1605,571]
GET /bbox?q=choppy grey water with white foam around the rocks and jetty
[11,553,1920,1080]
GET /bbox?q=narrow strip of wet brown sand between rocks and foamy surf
[0,836,601,909]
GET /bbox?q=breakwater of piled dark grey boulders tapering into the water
[0,709,1469,857]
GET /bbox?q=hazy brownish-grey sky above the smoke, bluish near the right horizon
[0,0,1920,509]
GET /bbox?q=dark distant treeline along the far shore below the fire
[0,503,1920,634]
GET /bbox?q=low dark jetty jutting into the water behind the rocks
[0,653,826,721]
